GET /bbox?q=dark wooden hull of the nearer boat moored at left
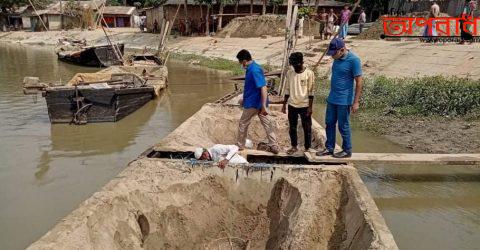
[44,86,155,123]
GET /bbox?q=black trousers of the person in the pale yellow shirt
[288,105,312,149]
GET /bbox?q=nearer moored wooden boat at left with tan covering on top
[24,73,155,124]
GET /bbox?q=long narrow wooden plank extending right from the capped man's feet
[305,153,480,165]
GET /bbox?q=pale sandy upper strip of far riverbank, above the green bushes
[0,28,480,79]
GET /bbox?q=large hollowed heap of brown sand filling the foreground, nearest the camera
[29,159,396,249]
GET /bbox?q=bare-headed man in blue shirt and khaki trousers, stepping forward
[237,50,279,154]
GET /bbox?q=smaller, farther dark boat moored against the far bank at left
[55,40,125,67]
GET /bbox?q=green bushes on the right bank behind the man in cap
[318,76,480,118]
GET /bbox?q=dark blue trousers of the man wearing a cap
[325,103,352,153]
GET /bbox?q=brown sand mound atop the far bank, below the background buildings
[217,15,319,38]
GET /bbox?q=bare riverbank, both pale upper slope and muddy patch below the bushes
[0,28,480,153]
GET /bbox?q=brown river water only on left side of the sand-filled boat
[0,44,233,249]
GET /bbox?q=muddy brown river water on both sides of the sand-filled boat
[0,44,480,249]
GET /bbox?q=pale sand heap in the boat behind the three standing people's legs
[155,104,325,151]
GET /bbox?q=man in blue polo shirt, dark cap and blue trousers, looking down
[317,38,362,158]
